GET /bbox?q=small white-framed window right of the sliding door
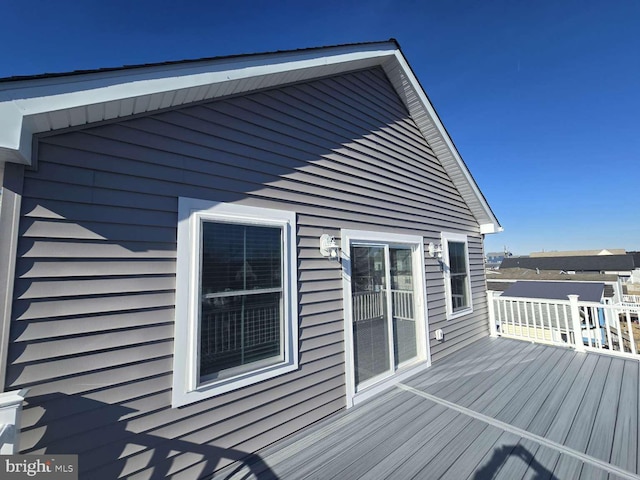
[442,232,473,318]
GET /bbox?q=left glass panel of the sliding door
[351,246,391,386]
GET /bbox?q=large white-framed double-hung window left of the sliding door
[172,198,298,407]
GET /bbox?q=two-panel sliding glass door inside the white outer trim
[351,243,418,391]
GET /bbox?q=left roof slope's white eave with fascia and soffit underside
[0,42,396,165]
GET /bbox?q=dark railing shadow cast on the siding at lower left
[23,394,277,480]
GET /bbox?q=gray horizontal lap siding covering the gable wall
[6,65,487,478]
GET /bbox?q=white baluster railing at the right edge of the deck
[488,291,640,360]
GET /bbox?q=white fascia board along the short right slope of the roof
[388,50,502,233]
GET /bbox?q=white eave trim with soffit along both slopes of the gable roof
[0,41,501,229]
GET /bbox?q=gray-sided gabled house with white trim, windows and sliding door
[0,41,501,479]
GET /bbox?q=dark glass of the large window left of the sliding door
[200,222,283,380]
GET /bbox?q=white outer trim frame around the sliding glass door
[340,229,431,408]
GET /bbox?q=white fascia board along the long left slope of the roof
[0,43,396,165]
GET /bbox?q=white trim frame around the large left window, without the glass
[172,197,298,408]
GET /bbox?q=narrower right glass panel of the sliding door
[389,247,418,368]
